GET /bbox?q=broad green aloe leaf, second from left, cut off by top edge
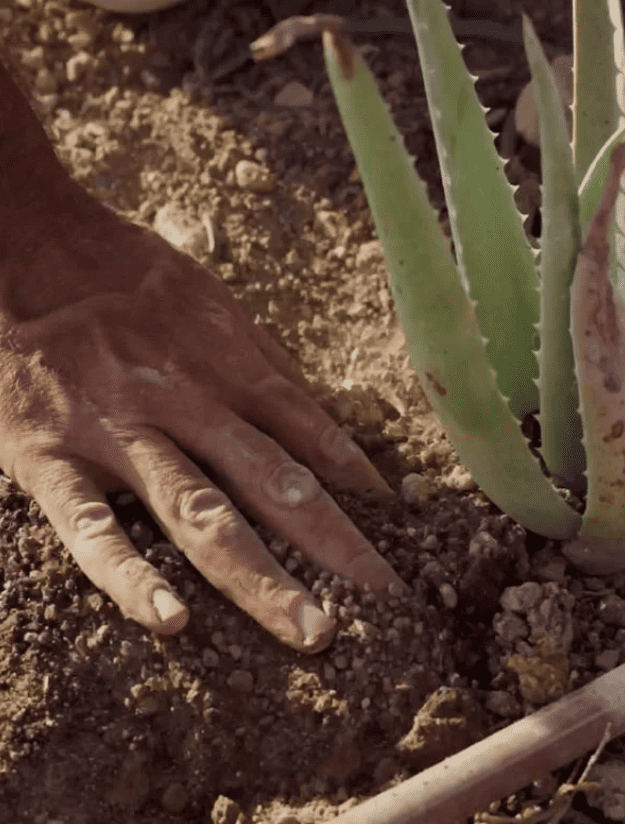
[407,0,538,417]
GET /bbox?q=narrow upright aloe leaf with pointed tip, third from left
[523,15,586,492]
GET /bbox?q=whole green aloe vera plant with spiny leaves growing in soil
[252,0,625,572]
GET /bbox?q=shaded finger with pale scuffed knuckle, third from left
[152,410,403,589]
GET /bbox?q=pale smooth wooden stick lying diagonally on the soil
[332,664,625,824]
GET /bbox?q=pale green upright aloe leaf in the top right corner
[573,0,625,183]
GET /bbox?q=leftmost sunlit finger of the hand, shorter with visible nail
[22,456,189,634]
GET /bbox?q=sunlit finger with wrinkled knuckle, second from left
[103,431,335,652]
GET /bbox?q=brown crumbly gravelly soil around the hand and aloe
[0,0,625,824]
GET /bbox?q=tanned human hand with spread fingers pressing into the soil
[0,184,403,652]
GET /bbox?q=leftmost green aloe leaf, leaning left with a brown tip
[323,31,581,538]
